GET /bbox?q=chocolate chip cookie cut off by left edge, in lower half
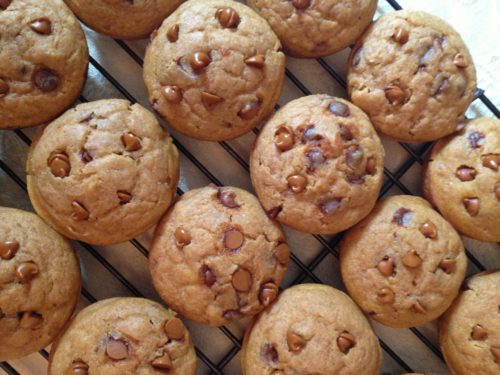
[0,207,81,362]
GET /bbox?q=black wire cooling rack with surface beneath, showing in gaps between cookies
[0,0,500,375]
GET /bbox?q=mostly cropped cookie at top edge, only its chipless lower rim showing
[65,0,183,39]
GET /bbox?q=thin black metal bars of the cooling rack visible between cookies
[0,0,500,374]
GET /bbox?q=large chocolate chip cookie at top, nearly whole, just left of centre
[144,0,285,141]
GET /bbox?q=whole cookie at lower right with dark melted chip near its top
[340,195,467,328]
